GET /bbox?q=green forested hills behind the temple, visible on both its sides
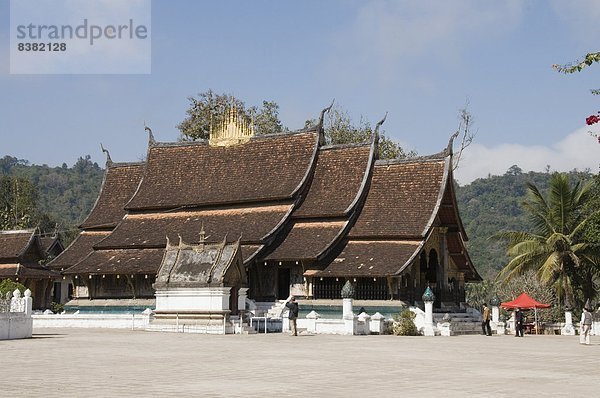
[0,156,592,278]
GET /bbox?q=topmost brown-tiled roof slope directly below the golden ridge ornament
[126,131,318,210]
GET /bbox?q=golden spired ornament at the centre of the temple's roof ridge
[208,104,255,146]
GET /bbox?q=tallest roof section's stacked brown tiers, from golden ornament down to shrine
[67,130,319,274]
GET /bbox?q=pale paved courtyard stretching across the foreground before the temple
[0,329,600,397]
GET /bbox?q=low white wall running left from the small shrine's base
[33,314,150,329]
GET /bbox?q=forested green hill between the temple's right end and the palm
[456,166,593,279]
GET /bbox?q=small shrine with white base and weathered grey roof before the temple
[151,228,248,334]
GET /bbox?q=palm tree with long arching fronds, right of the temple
[495,173,598,306]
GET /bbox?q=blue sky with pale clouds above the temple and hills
[0,0,600,183]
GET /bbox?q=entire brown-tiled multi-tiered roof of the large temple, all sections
[55,122,479,279]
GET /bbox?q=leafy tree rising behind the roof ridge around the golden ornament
[177,90,286,141]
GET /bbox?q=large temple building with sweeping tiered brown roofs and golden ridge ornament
[50,106,481,313]
